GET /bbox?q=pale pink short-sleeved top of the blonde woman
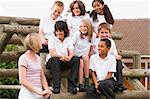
[18,52,42,89]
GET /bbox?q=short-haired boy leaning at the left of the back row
[39,1,64,52]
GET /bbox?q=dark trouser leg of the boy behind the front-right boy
[114,60,123,87]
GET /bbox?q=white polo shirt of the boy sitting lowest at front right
[90,54,116,81]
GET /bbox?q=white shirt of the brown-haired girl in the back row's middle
[67,13,90,37]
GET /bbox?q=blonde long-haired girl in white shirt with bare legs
[73,19,96,92]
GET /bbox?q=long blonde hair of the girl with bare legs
[81,19,93,42]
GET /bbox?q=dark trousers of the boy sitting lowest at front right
[86,78,116,99]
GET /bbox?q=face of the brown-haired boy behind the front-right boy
[98,28,111,38]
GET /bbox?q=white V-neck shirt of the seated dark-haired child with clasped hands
[46,36,74,61]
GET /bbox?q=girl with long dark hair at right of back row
[90,0,114,33]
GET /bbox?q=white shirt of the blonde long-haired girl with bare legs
[73,31,96,57]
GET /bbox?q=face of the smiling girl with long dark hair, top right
[92,1,104,13]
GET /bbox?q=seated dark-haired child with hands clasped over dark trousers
[47,21,80,94]
